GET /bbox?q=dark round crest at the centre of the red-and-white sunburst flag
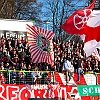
[36,35,50,52]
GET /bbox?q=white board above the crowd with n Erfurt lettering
[0,19,33,39]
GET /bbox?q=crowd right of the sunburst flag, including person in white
[54,40,100,81]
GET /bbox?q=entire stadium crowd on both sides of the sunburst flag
[0,37,100,84]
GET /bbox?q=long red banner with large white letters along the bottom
[0,84,99,100]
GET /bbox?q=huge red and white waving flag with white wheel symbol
[62,0,100,57]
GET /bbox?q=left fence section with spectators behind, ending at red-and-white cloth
[0,70,54,84]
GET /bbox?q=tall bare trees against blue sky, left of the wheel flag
[41,0,88,40]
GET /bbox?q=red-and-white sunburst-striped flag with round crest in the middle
[26,25,54,65]
